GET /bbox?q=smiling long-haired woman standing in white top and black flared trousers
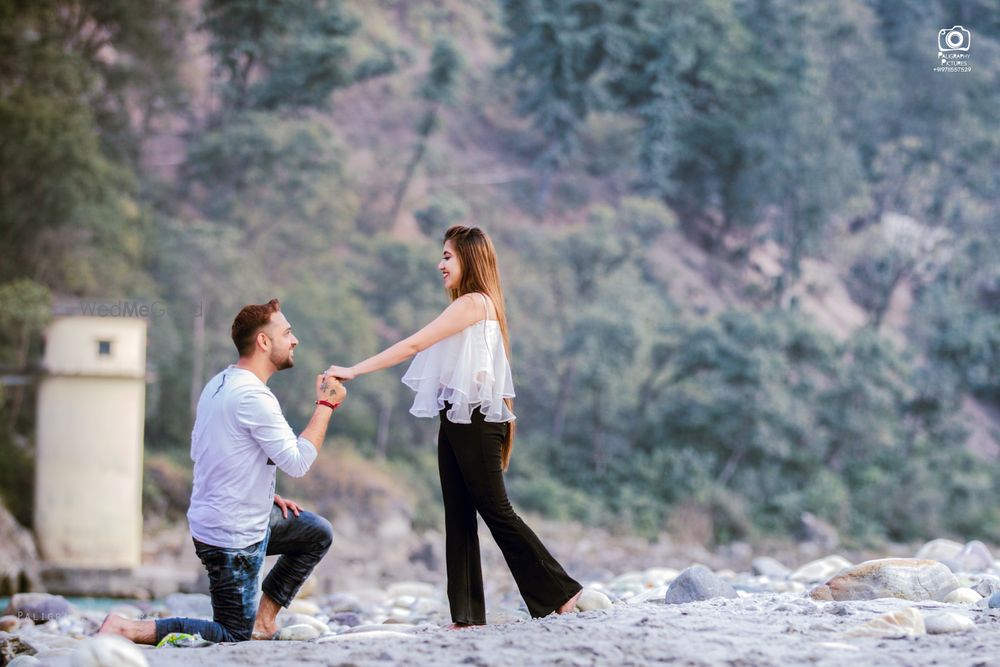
[326,225,582,627]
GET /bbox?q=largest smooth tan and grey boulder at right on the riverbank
[809,558,959,601]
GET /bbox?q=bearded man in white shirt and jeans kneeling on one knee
[99,299,347,644]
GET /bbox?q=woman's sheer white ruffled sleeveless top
[403,298,515,424]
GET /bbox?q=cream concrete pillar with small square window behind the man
[35,304,147,569]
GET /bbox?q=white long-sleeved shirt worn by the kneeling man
[187,366,317,548]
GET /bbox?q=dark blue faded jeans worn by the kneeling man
[156,505,333,643]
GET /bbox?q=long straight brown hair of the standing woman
[444,225,516,471]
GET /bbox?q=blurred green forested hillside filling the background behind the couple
[0,0,1000,540]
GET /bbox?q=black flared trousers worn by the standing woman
[438,407,581,625]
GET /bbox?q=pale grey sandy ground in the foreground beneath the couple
[72,593,1000,667]
